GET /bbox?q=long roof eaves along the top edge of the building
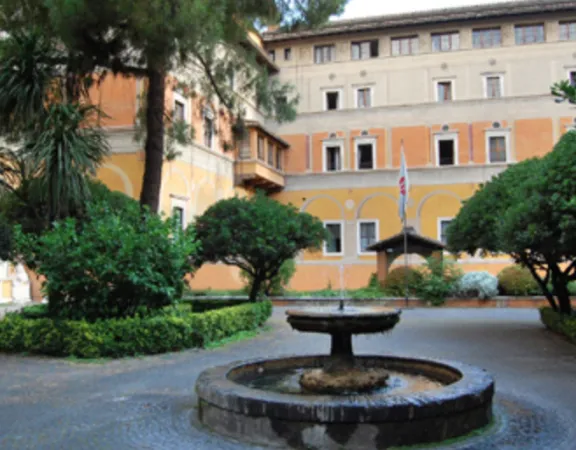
[262,0,576,43]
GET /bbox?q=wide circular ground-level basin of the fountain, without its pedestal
[196,355,494,450]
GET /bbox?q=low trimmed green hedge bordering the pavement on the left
[0,301,272,358]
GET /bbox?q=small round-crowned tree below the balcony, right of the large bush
[195,193,326,301]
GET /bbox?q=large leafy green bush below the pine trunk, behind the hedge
[15,203,197,321]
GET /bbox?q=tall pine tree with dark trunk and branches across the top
[2,0,347,211]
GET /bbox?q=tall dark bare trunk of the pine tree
[140,68,166,213]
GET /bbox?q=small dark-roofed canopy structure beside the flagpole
[367,227,446,283]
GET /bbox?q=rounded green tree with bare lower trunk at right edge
[448,132,576,314]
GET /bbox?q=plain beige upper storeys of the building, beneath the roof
[265,1,576,116]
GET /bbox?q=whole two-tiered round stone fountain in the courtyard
[196,302,494,450]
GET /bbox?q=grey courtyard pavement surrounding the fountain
[0,308,576,450]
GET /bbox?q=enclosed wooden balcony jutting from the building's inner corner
[234,122,289,191]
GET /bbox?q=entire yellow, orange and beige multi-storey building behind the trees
[79,1,576,290]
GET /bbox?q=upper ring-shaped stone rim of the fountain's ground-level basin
[196,355,494,423]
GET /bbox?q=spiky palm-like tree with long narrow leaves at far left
[0,29,109,228]
